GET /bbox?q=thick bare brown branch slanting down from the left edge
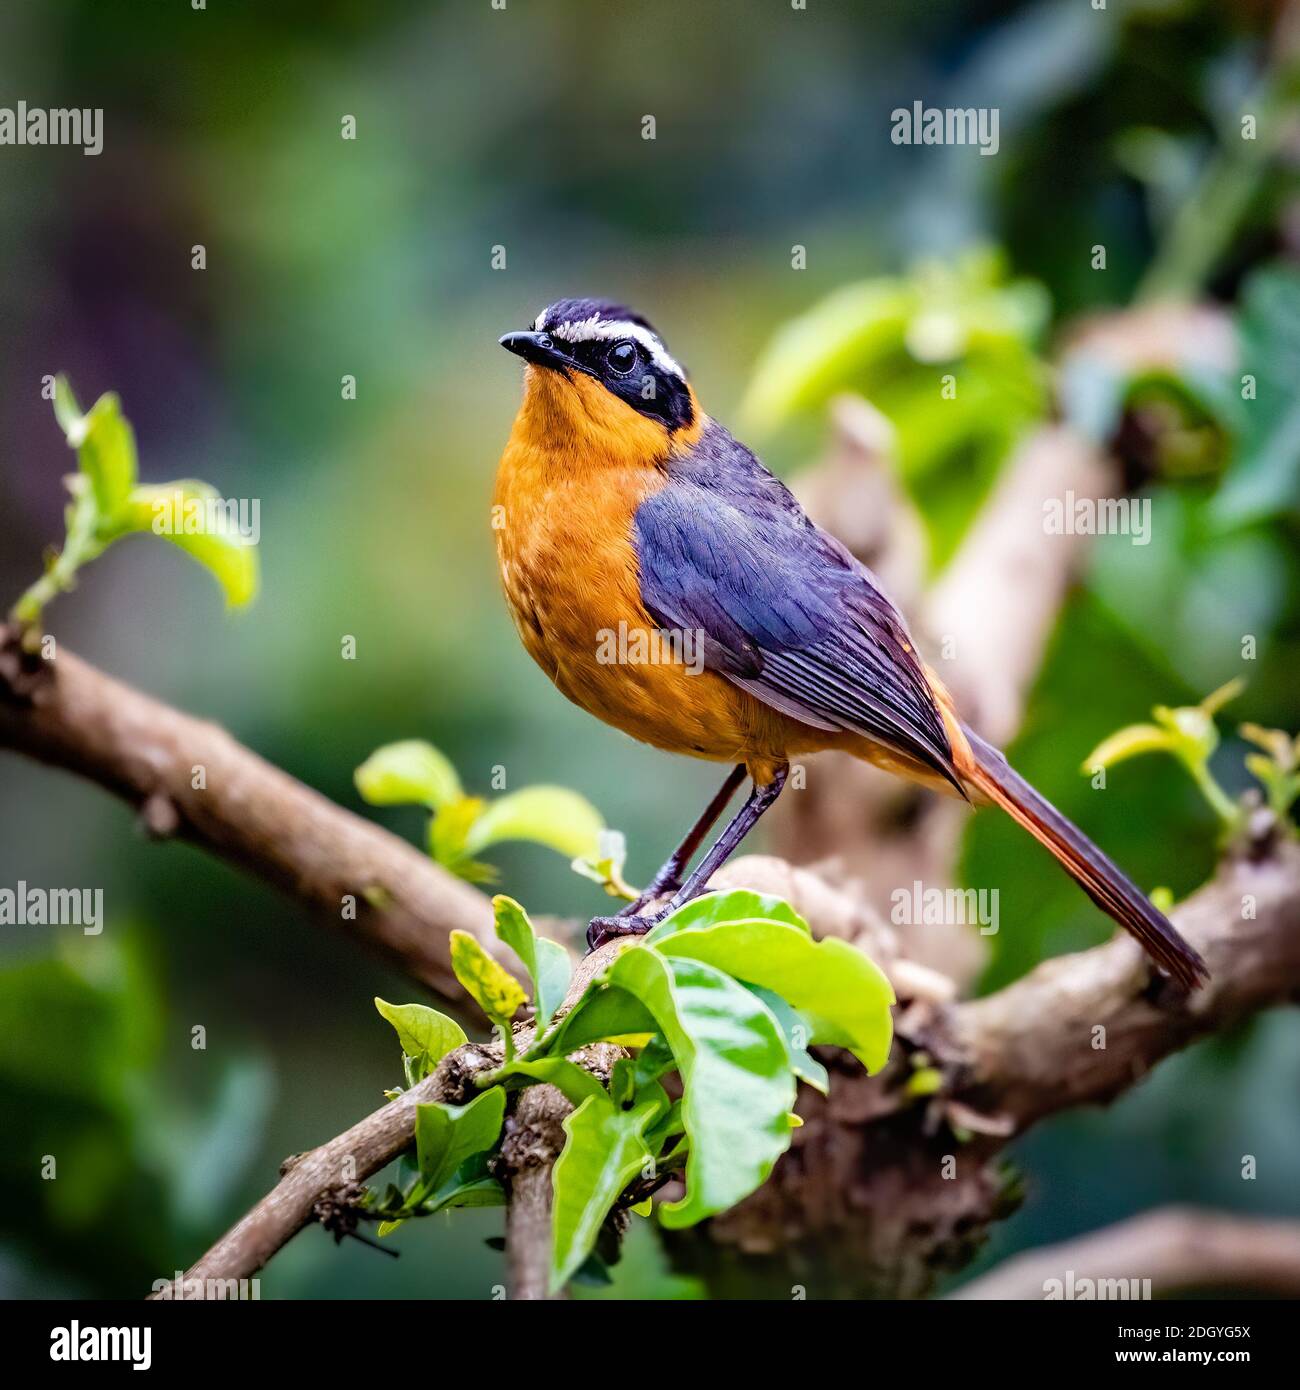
[0,627,498,999]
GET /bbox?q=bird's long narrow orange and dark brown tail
[961,726,1210,990]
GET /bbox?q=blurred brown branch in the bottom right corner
[952,1207,1300,1300]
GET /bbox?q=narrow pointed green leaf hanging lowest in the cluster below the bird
[551,1091,659,1293]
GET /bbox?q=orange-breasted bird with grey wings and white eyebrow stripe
[492,297,1208,990]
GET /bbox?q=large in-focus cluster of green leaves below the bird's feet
[368,890,894,1289]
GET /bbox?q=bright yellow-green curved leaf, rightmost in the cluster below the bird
[656,922,894,1072]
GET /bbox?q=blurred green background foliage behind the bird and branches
[0,0,1300,1297]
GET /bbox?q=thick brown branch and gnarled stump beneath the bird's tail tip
[674,840,1300,1297]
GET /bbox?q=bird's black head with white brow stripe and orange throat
[501,299,701,455]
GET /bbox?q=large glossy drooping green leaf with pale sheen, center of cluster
[609,950,798,1227]
